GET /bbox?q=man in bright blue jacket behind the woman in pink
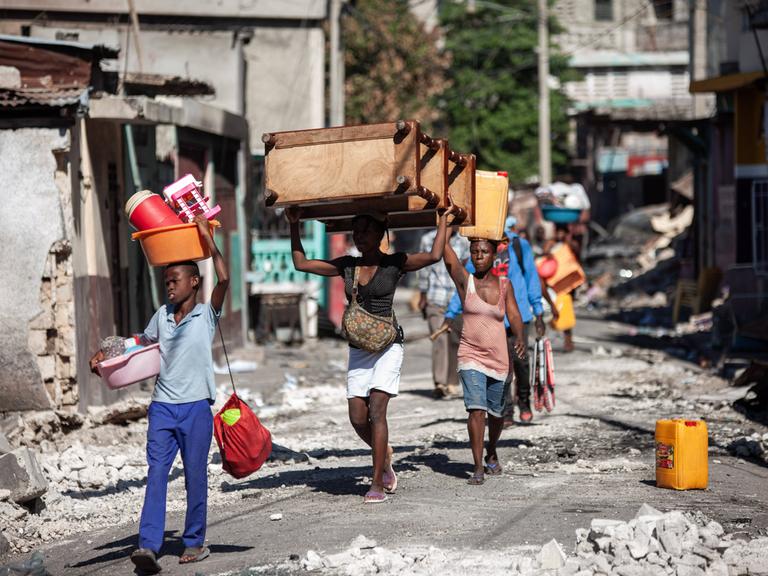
[445,216,546,425]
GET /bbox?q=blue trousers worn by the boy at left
[139,400,213,553]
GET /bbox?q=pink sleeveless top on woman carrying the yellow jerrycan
[459,274,509,380]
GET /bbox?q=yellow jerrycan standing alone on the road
[656,419,709,490]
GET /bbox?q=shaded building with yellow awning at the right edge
[690,0,768,352]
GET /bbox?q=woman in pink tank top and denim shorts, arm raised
[444,238,525,484]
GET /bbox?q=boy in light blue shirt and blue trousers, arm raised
[90,215,229,574]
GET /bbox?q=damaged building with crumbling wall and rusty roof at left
[0,35,248,412]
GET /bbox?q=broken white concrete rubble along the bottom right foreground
[266,504,768,576]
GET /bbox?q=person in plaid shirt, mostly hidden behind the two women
[419,229,469,398]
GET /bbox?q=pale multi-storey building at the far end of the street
[554,0,694,225]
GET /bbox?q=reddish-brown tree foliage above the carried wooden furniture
[342,0,447,126]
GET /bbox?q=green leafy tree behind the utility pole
[437,0,568,182]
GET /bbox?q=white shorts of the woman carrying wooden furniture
[347,344,403,398]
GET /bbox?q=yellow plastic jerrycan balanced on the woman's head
[459,170,509,242]
